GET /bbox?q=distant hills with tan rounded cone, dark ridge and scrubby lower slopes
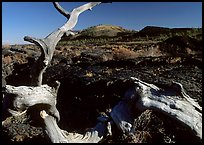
[61,25,202,43]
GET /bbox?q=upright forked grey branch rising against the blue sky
[24,2,101,86]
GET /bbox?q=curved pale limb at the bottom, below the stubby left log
[40,110,110,143]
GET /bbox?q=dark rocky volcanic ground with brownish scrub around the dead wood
[2,36,202,143]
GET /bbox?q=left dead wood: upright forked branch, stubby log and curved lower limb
[3,2,112,142]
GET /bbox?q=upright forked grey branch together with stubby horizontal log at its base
[4,2,104,118]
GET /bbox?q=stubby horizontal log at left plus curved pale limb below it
[3,83,111,143]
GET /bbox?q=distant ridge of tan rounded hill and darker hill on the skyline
[60,24,202,40]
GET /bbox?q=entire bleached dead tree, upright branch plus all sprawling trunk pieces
[3,2,202,143]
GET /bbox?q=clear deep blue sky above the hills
[2,2,202,44]
